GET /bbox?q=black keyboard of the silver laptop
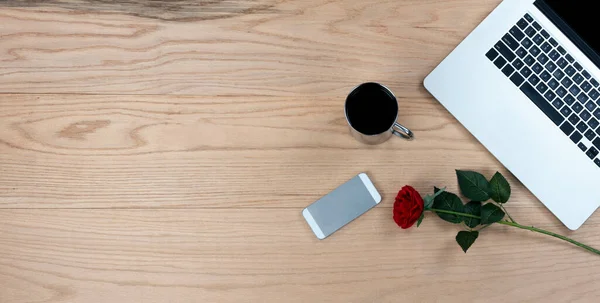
[486,14,600,167]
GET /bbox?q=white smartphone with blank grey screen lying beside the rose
[302,173,381,240]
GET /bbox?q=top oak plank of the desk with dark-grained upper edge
[0,0,499,96]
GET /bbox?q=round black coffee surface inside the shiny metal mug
[346,83,398,135]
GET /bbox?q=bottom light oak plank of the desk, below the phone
[0,207,600,303]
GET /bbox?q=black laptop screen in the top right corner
[535,0,600,67]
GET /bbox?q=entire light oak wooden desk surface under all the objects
[0,0,600,303]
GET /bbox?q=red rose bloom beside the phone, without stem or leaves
[394,185,425,229]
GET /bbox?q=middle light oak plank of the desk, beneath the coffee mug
[0,95,537,208]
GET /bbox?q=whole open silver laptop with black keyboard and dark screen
[425,0,600,230]
